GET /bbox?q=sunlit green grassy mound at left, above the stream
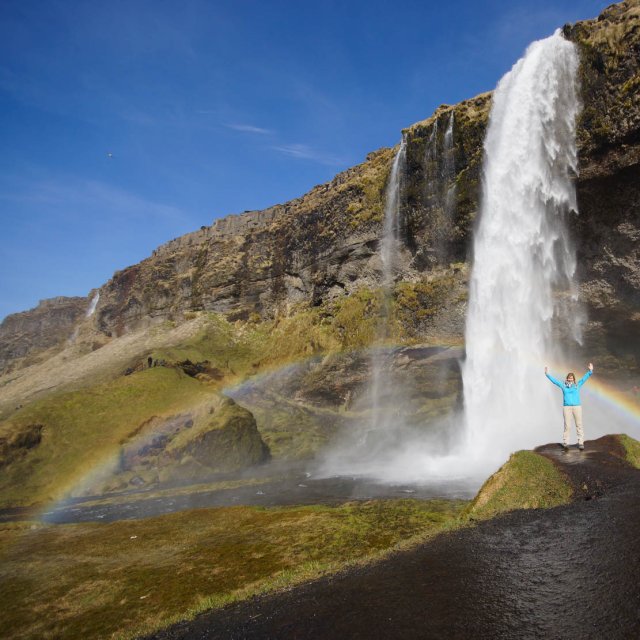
[0,367,215,506]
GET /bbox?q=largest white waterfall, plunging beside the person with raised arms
[463,31,580,466]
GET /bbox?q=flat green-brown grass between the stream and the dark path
[0,500,463,639]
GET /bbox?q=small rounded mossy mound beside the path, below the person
[466,451,573,519]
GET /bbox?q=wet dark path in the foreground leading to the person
[146,437,640,640]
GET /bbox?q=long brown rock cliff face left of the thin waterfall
[98,149,393,335]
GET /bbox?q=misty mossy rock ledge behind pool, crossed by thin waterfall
[227,345,463,459]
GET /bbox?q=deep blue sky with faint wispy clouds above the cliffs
[0,0,609,319]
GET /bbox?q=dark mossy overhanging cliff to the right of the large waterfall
[564,0,640,369]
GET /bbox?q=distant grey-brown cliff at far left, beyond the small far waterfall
[0,297,89,373]
